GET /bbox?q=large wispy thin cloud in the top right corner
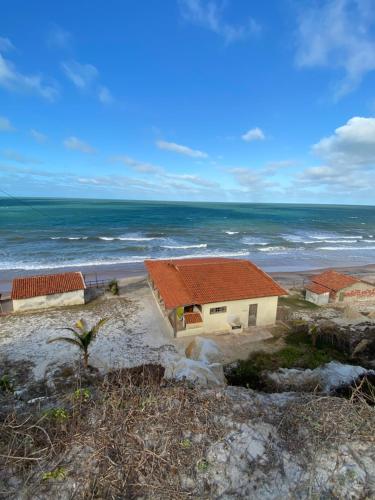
[296,0,375,98]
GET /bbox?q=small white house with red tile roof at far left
[11,272,86,312]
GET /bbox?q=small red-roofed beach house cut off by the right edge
[305,270,375,305]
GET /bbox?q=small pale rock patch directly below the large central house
[164,358,225,386]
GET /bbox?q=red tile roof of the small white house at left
[11,273,86,300]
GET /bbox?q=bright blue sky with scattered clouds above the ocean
[0,0,375,205]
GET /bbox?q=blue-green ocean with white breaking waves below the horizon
[0,198,375,278]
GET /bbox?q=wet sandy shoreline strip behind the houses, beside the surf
[0,262,375,294]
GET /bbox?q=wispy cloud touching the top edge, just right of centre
[179,0,261,43]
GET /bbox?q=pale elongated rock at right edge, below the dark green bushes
[264,361,375,394]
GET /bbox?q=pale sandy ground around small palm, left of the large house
[0,279,175,379]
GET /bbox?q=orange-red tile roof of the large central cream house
[145,258,287,309]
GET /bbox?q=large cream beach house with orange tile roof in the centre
[145,258,287,337]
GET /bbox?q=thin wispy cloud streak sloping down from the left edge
[0,54,59,101]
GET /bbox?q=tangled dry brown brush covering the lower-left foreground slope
[0,365,231,499]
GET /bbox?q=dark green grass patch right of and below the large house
[226,329,348,390]
